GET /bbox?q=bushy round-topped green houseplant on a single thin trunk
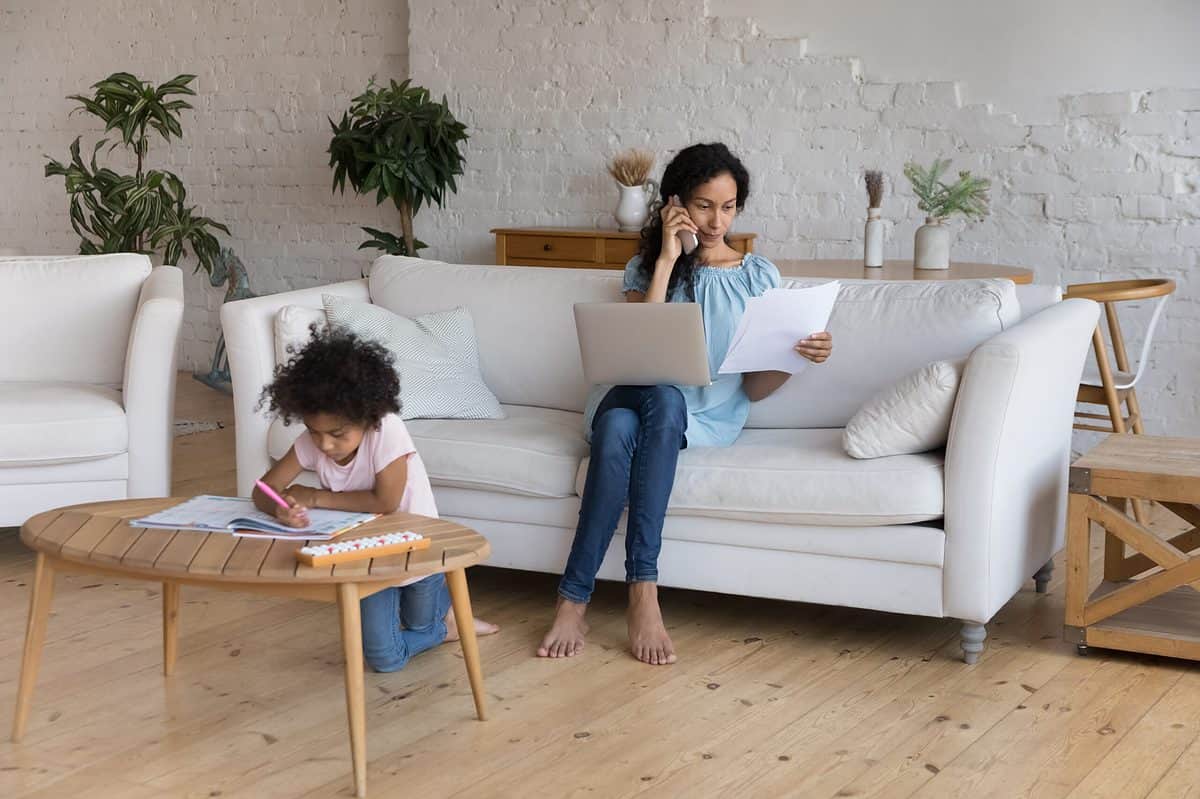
[329,79,468,256]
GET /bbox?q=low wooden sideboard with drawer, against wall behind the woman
[492,228,756,269]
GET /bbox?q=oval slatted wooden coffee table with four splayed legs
[12,498,491,797]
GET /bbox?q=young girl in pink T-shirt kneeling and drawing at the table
[252,331,499,672]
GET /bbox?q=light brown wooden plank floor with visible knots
[0,379,1200,799]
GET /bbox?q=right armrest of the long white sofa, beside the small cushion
[942,300,1099,623]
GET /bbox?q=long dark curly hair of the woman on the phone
[637,142,750,300]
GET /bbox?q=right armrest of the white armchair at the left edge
[121,266,184,497]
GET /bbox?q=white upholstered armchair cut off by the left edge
[0,253,184,527]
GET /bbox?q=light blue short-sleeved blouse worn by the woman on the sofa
[583,254,780,447]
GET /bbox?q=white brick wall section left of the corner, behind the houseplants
[0,0,408,368]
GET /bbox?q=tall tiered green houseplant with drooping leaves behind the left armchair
[46,72,229,274]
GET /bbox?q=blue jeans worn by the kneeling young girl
[359,575,450,672]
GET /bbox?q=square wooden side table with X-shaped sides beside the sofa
[1063,434,1200,660]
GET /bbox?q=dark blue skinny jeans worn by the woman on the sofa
[558,385,688,602]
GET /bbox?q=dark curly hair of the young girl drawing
[258,325,400,427]
